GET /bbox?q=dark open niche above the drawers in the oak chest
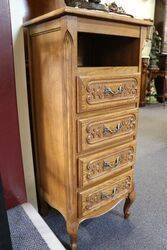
[78,32,140,67]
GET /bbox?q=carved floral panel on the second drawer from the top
[86,115,136,144]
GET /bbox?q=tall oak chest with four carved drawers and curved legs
[25,7,151,249]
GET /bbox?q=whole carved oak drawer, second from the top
[78,109,138,153]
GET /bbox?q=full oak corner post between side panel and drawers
[62,17,78,224]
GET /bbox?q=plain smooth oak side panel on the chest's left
[30,28,67,217]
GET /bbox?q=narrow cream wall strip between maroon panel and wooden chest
[9,0,37,208]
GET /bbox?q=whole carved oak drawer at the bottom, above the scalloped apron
[78,170,134,217]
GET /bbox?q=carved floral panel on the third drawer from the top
[87,147,134,180]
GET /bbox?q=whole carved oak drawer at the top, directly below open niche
[77,76,139,113]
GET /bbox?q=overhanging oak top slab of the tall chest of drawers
[24,7,153,27]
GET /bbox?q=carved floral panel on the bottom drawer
[84,176,132,210]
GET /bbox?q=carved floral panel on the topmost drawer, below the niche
[86,80,137,104]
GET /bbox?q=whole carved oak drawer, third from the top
[78,142,136,187]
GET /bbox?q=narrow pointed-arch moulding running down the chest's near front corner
[62,29,77,217]
